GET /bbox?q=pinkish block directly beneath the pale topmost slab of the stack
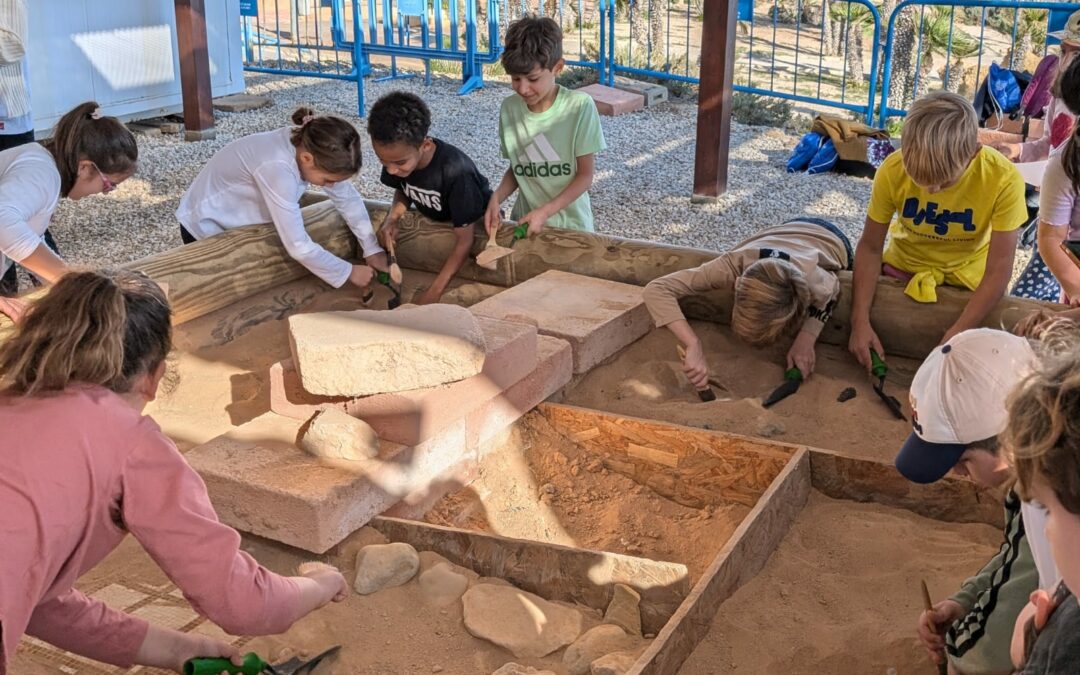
[270,316,537,445]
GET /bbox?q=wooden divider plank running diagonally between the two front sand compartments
[627,449,810,675]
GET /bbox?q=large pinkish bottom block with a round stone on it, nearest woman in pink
[185,413,477,553]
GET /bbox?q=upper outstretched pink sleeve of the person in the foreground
[122,432,300,635]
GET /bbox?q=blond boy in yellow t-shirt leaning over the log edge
[849,92,1027,368]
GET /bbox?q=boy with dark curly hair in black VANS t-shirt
[367,92,491,305]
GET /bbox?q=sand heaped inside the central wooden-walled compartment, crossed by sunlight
[426,413,750,580]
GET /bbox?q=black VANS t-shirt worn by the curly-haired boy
[379,138,491,227]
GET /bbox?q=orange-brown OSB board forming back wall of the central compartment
[539,403,798,509]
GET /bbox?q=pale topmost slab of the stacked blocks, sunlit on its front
[288,305,485,396]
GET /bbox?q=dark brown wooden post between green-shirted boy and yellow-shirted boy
[691,0,738,203]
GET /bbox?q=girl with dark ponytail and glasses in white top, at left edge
[0,100,138,321]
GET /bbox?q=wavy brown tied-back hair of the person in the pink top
[0,270,172,396]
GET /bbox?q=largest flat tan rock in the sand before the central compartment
[461,583,584,659]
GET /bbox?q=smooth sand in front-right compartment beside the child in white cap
[680,491,1001,675]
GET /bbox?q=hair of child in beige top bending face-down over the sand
[731,258,810,347]
